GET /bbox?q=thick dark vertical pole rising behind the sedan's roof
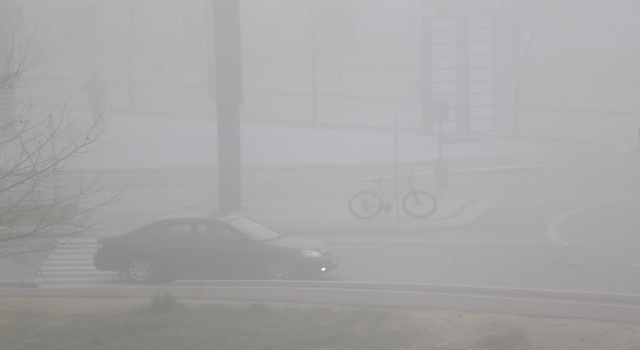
[210,0,244,211]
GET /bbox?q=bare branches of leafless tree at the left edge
[0,13,113,267]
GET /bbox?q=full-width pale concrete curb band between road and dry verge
[0,281,640,323]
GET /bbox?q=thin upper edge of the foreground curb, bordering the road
[0,280,640,307]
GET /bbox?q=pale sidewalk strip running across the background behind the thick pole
[70,115,547,171]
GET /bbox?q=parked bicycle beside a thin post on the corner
[349,175,438,220]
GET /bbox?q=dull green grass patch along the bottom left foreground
[0,294,406,350]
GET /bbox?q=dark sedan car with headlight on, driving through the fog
[93,214,340,283]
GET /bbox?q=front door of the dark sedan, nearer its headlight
[193,224,255,278]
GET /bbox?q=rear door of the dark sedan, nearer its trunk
[152,222,197,277]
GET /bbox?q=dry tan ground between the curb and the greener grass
[0,297,640,350]
